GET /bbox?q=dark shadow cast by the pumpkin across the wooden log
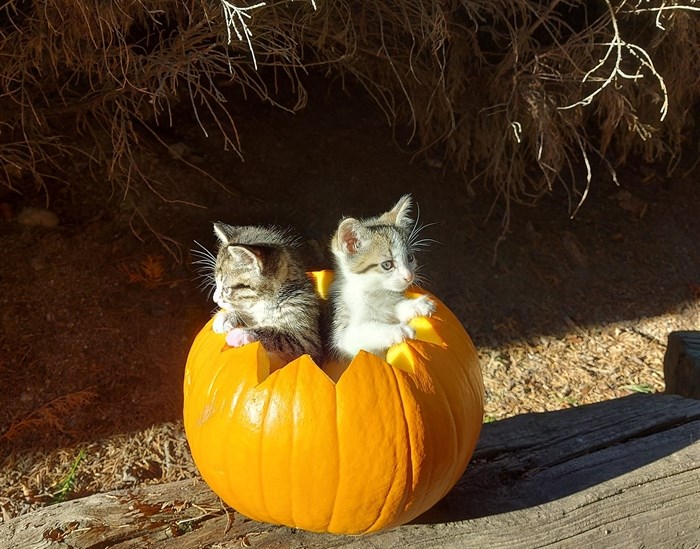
[413,395,700,524]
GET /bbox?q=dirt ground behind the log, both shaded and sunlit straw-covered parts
[0,88,700,520]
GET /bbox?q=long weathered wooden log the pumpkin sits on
[0,395,700,549]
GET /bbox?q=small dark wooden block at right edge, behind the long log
[664,332,700,399]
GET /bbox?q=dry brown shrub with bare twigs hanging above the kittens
[0,0,700,223]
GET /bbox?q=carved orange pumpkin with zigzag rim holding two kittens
[184,271,483,534]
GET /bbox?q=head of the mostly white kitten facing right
[331,194,416,292]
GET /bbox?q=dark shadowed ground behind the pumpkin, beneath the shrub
[0,85,700,456]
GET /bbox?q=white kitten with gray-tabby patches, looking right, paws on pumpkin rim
[328,195,435,360]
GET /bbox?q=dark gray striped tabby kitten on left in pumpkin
[208,223,322,364]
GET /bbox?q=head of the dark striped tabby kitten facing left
[214,223,296,311]
